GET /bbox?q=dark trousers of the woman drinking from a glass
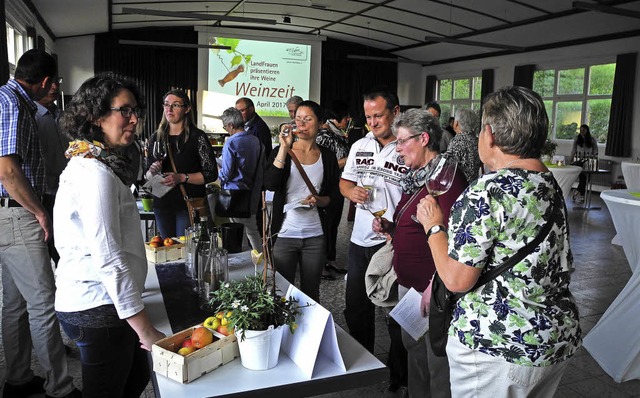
[273,236,327,303]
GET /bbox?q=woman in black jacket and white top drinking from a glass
[264,101,342,301]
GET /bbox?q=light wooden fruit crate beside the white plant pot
[151,325,240,383]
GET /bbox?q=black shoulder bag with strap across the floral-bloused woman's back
[429,204,561,357]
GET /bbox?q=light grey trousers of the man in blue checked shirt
[0,207,74,396]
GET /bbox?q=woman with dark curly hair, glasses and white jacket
[54,74,164,397]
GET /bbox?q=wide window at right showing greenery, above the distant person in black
[533,63,616,143]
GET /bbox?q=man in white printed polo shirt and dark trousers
[340,90,407,358]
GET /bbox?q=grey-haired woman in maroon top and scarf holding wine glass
[373,109,466,397]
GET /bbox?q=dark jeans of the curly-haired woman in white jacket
[60,321,151,398]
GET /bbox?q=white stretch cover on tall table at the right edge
[584,190,640,383]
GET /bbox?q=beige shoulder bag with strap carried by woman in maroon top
[364,187,424,307]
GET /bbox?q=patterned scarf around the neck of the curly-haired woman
[64,140,136,186]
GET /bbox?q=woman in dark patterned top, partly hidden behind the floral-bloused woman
[446,109,482,183]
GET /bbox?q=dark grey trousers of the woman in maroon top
[398,285,451,398]
